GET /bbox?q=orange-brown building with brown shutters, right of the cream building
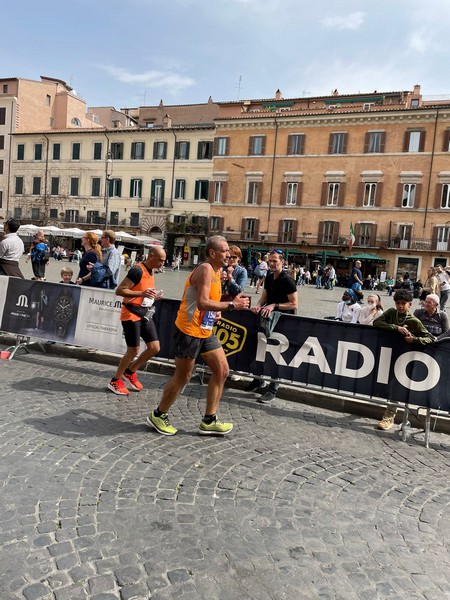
[210,86,450,278]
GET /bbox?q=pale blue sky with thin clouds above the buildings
[0,0,450,109]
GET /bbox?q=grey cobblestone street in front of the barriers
[0,353,450,600]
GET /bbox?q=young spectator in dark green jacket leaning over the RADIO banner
[373,289,436,430]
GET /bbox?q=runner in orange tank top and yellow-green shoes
[147,235,249,435]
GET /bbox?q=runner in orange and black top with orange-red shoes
[108,246,166,396]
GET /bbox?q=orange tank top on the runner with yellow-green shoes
[175,267,222,338]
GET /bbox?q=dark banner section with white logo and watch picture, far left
[0,277,81,344]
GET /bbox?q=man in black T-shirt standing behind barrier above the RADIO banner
[246,250,298,404]
